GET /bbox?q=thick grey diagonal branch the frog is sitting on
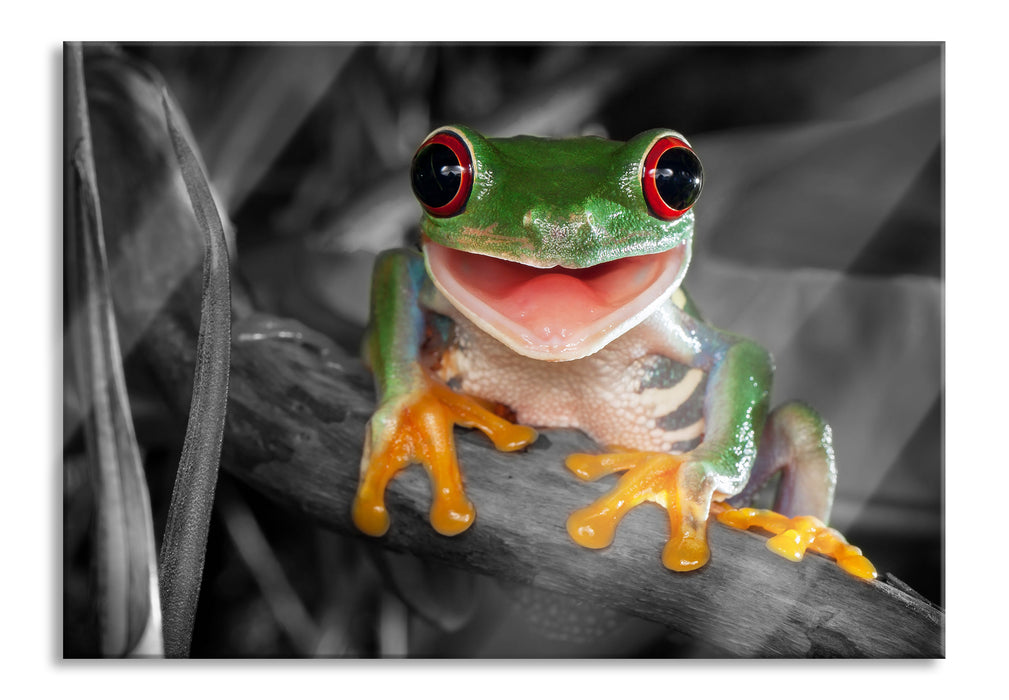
[155,312,944,657]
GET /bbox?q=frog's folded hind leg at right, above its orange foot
[728,401,837,522]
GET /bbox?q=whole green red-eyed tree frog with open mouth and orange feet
[351,124,875,578]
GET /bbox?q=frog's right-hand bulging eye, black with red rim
[641,136,704,221]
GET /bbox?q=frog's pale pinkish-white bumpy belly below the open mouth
[438,310,706,452]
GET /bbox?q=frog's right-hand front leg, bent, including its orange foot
[567,304,773,571]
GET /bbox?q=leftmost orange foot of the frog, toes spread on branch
[353,377,537,537]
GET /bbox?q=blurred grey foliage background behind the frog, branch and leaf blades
[64,43,944,657]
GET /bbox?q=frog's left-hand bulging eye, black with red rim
[410,131,473,217]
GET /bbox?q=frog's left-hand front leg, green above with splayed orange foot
[353,250,536,537]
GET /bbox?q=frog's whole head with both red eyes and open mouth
[411,126,701,360]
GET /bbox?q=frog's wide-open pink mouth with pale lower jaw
[423,239,690,361]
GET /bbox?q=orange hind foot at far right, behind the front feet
[717,504,876,580]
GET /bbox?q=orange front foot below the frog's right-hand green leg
[565,452,714,571]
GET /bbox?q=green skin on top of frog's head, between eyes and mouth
[421,127,693,267]
